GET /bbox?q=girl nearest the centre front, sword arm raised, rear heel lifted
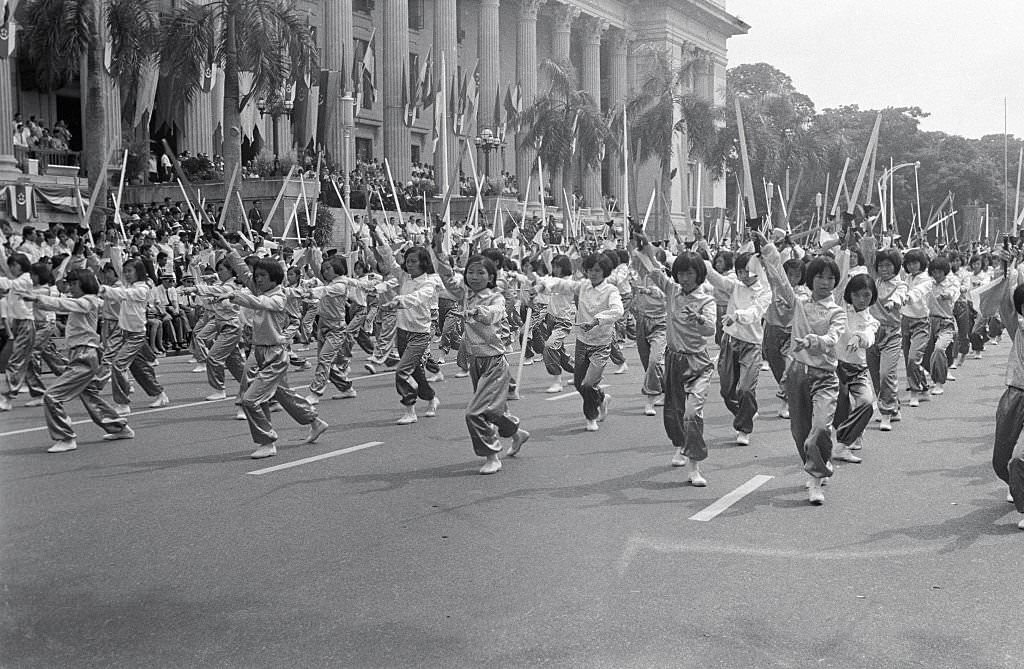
[433,243,529,474]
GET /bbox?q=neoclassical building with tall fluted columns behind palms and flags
[0,0,749,225]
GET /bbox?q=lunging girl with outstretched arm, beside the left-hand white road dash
[228,258,328,458]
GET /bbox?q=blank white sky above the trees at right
[726,0,1024,138]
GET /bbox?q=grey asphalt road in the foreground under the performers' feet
[0,344,1024,669]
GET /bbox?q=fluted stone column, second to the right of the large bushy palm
[381,0,412,182]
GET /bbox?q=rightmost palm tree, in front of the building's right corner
[615,49,725,236]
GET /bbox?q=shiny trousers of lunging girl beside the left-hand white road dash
[241,344,316,446]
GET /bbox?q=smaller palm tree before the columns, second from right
[519,59,612,221]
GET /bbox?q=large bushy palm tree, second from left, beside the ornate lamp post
[161,0,319,228]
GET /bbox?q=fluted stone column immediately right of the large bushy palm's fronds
[321,0,354,171]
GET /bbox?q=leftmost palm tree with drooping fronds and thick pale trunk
[15,0,159,226]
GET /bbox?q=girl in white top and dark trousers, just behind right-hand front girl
[835,275,879,463]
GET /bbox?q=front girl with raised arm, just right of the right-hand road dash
[761,236,847,504]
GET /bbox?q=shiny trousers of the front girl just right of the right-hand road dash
[785,361,839,478]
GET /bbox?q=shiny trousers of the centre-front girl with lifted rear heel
[466,356,519,457]
